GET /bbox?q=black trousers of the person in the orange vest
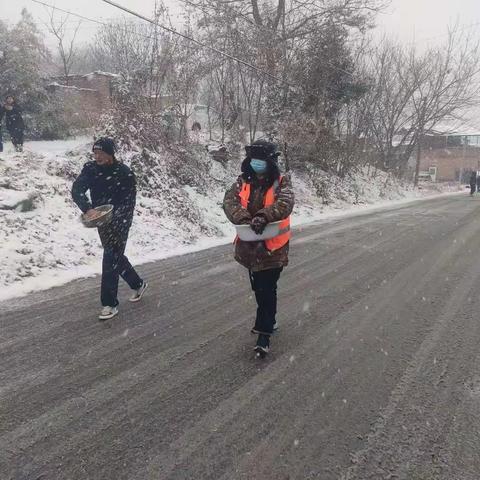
[249,268,283,335]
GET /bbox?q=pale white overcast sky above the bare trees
[0,0,480,44]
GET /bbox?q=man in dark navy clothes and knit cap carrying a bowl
[72,137,148,320]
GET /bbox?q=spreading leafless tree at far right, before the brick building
[354,28,480,184]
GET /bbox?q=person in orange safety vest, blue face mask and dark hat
[223,140,294,357]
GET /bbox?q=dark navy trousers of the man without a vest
[98,226,143,307]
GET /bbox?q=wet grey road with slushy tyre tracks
[0,196,480,480]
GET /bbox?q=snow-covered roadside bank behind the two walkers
[0,138,464,300]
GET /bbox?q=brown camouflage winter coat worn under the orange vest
[223,159,295,272]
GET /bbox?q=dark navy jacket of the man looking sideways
[72,161,137,239]
